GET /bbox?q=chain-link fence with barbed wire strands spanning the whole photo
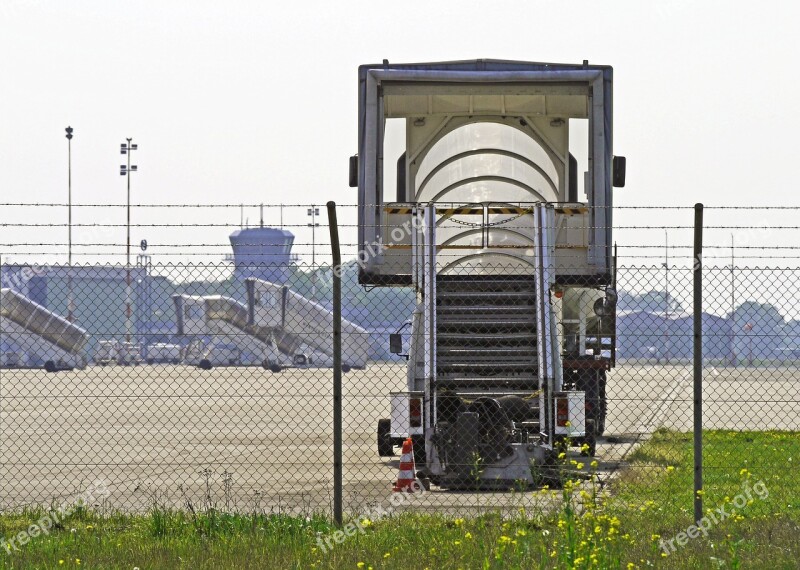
[0,204,800,515]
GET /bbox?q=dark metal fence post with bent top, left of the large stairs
[324,201,343,525]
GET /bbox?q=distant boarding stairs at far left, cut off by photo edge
[0,288,89,372]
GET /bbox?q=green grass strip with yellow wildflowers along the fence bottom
[0,431,800,570]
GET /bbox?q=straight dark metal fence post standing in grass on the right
[692,203,703,522]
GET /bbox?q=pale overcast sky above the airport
[0,0,800,270]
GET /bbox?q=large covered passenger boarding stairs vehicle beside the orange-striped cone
[350,60,625,488]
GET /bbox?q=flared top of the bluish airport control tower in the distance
[228,226,294,283]
